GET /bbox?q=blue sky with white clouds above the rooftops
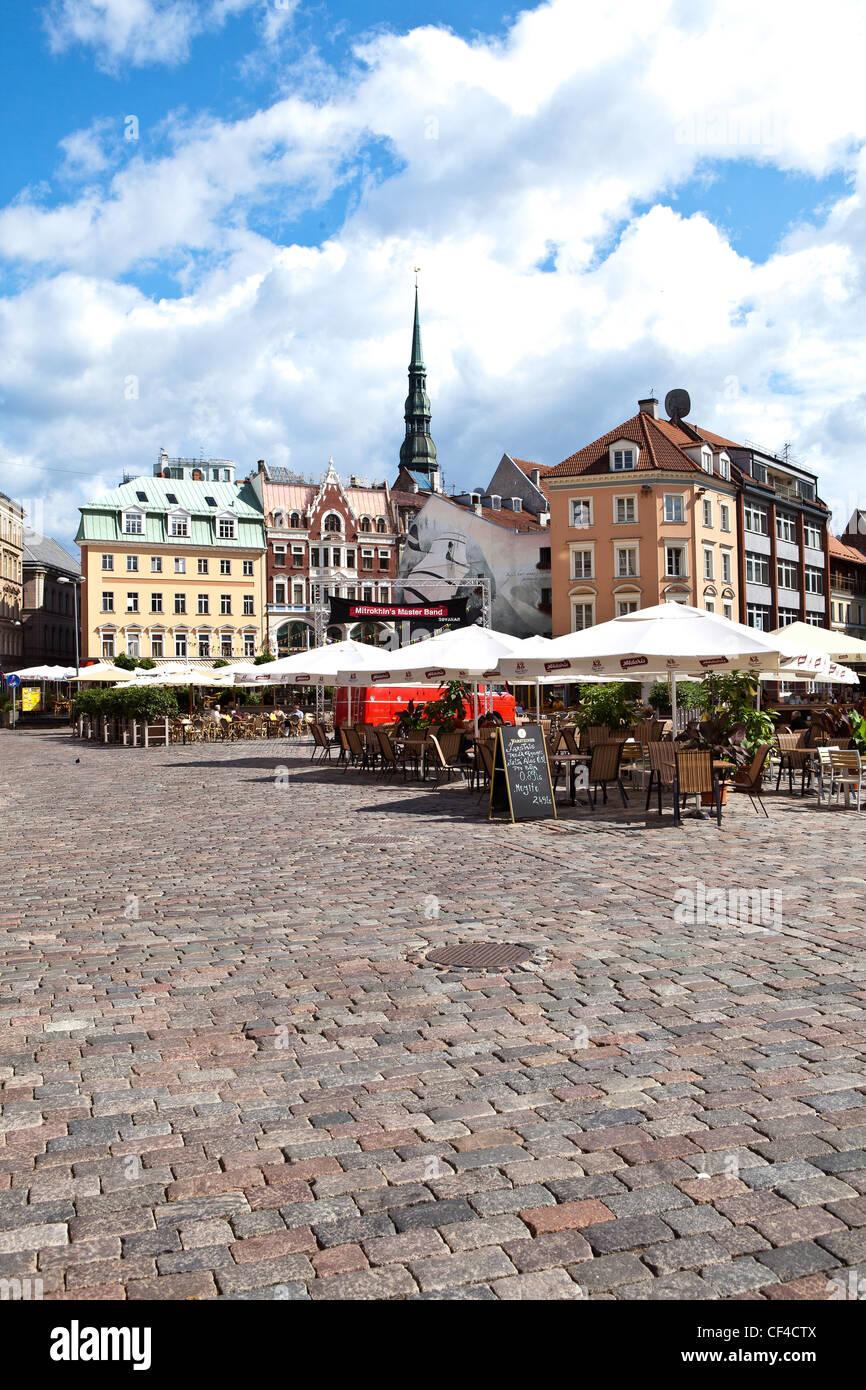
[0,0,866,538]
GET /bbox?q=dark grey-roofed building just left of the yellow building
[21,530,81,666]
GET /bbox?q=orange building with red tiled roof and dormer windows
[545,399,741,637]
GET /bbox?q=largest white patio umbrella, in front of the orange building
[499,603,856,721]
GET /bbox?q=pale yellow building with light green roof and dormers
[75,455,267,660]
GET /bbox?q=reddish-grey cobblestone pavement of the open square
[0,733,866,1300]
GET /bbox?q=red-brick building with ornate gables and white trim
[249,460,399,656]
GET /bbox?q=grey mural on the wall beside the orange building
[396,496,550,637]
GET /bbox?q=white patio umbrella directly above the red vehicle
[338,626,521,733]
